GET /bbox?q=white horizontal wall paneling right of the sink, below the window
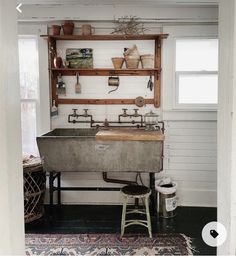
[161,121,217,207]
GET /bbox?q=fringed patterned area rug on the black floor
[26,234,193,256]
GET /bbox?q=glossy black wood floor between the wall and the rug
[25,205,217,255]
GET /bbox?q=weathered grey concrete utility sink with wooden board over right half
[37,129,164,173]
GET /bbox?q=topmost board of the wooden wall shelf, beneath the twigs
[41,34,168,40]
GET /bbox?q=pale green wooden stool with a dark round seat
[121,185,152,238]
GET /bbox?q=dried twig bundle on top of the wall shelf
[111,16,147,35]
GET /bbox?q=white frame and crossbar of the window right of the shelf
[173,36,219,111]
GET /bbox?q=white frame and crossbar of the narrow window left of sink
[18,34,41,154]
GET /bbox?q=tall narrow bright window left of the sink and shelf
[18,36,39,155]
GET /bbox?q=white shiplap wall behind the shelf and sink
[44,25,217,206]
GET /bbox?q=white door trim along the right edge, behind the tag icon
[217,0,236,255]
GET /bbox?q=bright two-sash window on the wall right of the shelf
[175,38,218,109]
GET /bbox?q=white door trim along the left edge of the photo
[0,0,25,256]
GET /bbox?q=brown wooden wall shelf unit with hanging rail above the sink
[41,34,168,108]
